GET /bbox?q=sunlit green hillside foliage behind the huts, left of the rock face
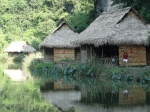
[0,0,93,51]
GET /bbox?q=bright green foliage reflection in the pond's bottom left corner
[0,81,57,112]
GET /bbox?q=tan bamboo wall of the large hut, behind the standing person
[119,46,147,66]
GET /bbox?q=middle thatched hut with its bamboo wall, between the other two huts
[39,22,80,61]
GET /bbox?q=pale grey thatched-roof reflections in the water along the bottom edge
[43,91,150,112]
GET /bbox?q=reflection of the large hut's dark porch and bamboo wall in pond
[81,85,147,105]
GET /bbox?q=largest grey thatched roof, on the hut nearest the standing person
[73,7,150,46]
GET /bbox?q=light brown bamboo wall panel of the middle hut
[54,48,75,61]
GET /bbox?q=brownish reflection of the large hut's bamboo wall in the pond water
[119,86,146,104]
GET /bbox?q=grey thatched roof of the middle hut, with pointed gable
[39,22,78,49]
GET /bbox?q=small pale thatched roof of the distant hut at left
[4,41,36,52]
